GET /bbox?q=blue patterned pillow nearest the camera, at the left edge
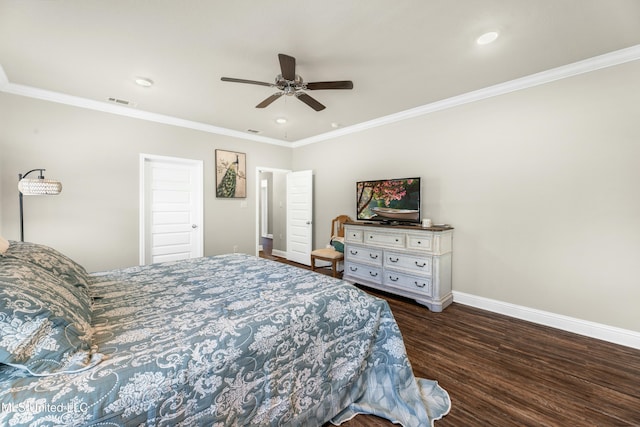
[0,257,103,376]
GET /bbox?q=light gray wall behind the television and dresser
[293,61,640,331]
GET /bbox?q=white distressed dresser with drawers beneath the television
[343,222,453,312]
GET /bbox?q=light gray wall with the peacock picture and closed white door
[0,93,291,271]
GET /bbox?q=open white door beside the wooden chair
[287,170,313,265]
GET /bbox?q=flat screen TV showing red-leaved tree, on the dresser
[356,178,421,223]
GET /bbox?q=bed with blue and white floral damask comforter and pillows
[0,242,451,427]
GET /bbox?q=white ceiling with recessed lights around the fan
[0,0,640,143]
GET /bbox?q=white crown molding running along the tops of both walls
[0,44,640,148]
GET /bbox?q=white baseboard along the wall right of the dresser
[453,291,640,350]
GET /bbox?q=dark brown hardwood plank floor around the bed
[258,257,640,427]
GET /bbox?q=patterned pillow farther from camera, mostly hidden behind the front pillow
[4,241,91,294]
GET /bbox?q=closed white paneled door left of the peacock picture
[140,155,203,264]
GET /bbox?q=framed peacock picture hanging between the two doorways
[215,150,247,199]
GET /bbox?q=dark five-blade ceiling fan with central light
[220,53,353,111]
